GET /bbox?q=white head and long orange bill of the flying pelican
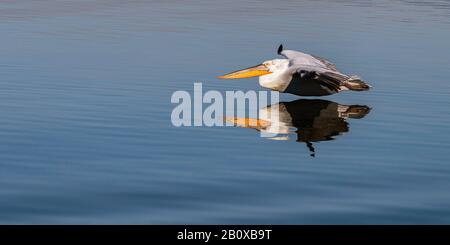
[217,59,289,79]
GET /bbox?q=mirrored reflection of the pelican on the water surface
[225,99,370,157]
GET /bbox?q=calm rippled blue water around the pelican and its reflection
[0,0,450,224]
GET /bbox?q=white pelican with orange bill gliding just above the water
[218,45,370,96]
